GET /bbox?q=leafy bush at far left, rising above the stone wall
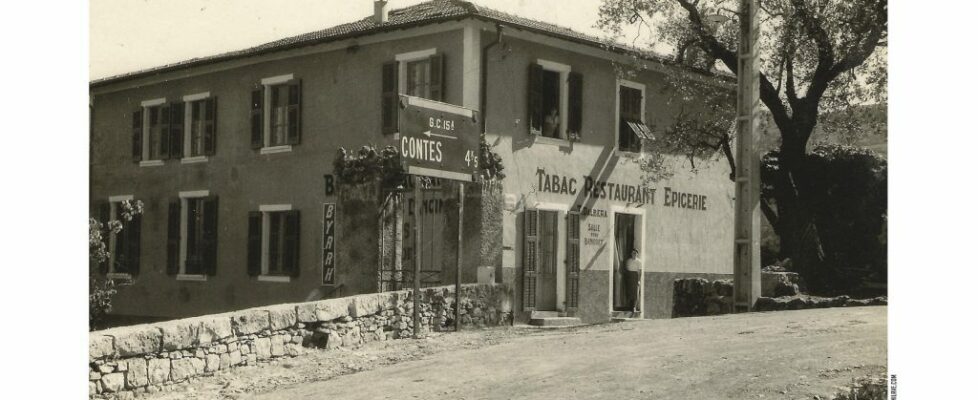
[88,200,143,330]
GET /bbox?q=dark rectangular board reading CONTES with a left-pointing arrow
[395,96,480,182]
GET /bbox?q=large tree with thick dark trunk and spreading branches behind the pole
[598,0,888,290]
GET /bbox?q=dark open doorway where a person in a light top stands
[612,213,642,312]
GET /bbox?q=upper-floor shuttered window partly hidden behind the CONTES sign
[381,49,445,135]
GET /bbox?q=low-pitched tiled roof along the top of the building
[90,0,688,87]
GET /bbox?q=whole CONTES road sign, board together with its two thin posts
[394,96,480,338]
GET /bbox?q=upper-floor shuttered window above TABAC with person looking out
[527,60,584,140]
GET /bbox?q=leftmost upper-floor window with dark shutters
[132,99,184,166]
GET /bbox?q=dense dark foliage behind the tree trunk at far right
[761,145,887,295]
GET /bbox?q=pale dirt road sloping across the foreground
[145,307,887,399]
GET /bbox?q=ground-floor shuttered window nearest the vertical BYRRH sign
[248,204,299,282]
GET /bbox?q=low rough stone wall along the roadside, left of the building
[89,284,512,397]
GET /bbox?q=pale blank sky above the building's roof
[89,0,656,79]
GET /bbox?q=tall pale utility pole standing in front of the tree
[734,0,761,312]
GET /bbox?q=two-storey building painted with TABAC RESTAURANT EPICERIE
[90,0,733,322]
